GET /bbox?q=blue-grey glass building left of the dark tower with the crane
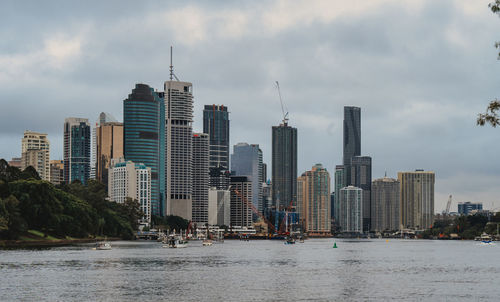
[231,143,264,213]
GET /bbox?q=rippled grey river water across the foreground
[0,239,500,301]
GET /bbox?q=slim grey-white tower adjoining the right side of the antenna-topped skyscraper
[192,133,209,224]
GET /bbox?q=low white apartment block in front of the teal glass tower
[108,157,151,225]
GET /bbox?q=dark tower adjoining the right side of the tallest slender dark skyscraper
[350,156,372,232]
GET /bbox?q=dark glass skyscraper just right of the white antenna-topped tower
[203,105,229,170]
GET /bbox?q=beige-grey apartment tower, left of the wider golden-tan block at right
[372,177,401,232]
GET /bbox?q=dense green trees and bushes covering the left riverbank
[0,159,142,247]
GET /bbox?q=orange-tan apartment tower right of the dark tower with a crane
[297,164,331,236]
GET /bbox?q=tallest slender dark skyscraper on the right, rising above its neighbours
[343,106,361,186]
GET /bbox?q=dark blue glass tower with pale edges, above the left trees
[63,117,90,184]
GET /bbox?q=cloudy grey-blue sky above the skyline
[0,0,500,212]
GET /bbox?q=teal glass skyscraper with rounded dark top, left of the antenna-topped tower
[123,84,165,216]
